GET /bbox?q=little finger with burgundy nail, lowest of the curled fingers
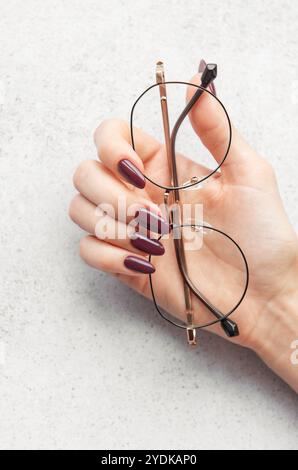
[80,236,155,276]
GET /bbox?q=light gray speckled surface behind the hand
[0,0,298,449]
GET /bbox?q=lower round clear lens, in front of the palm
[150,224,248,328]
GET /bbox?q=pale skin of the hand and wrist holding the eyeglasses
[70,70,298,392]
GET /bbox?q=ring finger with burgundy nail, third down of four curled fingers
[69,194,165,256]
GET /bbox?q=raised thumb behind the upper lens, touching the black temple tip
[187,74,259,182]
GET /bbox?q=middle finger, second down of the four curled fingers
[73,160,159,222]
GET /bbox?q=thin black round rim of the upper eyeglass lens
[129,81,232,191]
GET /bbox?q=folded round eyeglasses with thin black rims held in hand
[130,62,249,345]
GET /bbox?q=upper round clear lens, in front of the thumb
[131,82,231,189]
